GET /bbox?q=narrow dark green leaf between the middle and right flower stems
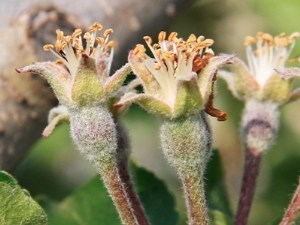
[206,150,233,225]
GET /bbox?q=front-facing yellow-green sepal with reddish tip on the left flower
[71,55,103,106]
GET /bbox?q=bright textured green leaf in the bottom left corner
[0,171,48,225]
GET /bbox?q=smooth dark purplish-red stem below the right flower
[234,149,261,225]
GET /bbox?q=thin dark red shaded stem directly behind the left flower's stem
[115,119,150,225]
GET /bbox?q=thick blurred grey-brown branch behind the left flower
[0,0,192,170]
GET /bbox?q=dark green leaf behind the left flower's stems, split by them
[45,164,178,225]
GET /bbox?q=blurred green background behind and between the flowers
[14,0,300,225]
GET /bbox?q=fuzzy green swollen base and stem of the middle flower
[161,113,211,225]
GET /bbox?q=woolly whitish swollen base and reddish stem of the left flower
[70,105,139,225]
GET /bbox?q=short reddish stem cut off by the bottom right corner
[280,180,300,225]
